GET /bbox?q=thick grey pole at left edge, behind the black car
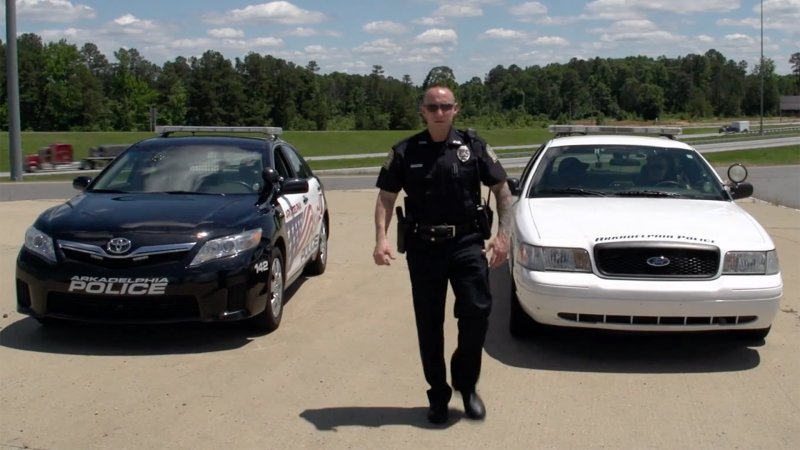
[6,0,22,181]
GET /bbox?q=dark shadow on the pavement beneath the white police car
[484,266,760,373]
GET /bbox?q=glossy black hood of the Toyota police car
[36,193,258,242]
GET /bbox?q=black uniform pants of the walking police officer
[406,234,492,403]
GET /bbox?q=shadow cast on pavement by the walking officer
[300,406,464,431]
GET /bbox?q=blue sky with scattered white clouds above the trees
[2,0,800,84]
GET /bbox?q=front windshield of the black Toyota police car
[89,138,263,194]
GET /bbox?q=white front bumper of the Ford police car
[513,264,783,331]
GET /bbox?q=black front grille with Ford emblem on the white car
[594,242,720,279]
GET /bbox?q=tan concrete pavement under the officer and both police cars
[0,189,800,450]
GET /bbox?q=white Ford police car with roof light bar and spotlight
[509,125,783,340]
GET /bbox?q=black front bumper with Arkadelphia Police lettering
[16,249,267,323]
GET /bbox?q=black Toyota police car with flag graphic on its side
[16,126,329,331]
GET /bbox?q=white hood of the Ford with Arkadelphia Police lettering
[515,197,774,250]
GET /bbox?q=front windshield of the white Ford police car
[527,144,728,200]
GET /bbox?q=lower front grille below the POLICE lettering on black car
[47,293,200,321]
